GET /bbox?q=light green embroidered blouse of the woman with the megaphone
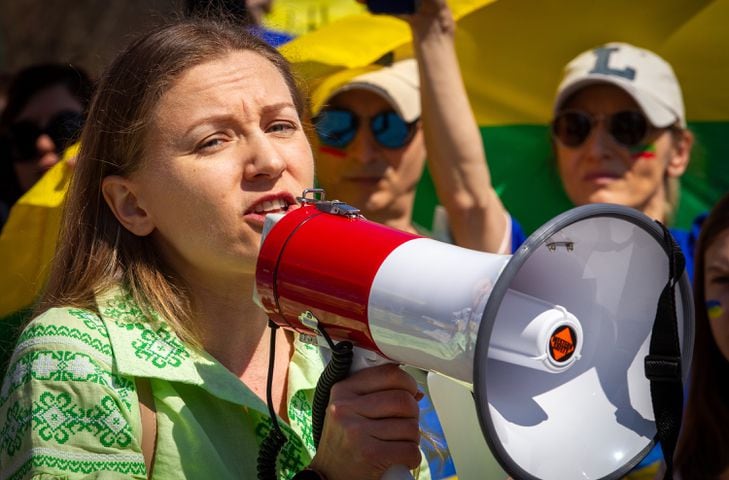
[0,291,322,480]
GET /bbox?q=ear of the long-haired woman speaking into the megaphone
[101,175,154,237]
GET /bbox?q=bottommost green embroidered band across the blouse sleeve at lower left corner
[8,448,147,480]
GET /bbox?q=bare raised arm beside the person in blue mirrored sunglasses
[404,0,511,253]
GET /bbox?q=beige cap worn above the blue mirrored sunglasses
[312,59,420,123]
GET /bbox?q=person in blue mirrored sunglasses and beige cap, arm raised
[312,0,512,253]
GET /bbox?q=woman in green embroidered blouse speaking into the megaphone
[0,19,427,480]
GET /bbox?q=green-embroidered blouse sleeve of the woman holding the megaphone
[0,309,146,480]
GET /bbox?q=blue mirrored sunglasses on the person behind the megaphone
[314,108,417,149]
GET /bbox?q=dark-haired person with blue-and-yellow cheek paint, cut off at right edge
[674,194,729,480]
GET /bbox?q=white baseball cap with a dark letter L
[554,42,686,128]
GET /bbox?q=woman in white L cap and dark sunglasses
[552,43,700,478]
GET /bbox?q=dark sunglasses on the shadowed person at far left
[4,110,84,162]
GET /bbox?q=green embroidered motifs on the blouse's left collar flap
[103,294,190,368]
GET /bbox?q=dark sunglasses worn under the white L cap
[552,110,649,148]
